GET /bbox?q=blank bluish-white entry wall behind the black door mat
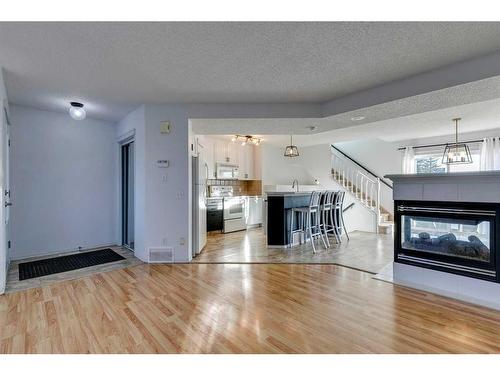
[11,105,116,259]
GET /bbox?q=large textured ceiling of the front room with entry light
[0,22,500,120]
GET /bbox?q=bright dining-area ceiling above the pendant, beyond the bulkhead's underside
[195,95,500,146]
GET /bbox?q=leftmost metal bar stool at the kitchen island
[290,191,327,254]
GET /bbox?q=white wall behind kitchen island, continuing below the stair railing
[261,143,376,232]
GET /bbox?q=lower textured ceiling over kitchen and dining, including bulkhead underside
[191,77,500,138]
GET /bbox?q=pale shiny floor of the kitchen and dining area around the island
[193,228,394,274]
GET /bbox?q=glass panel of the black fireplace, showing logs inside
[401,215,492,262]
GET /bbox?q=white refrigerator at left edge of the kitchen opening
[192,156,208,257]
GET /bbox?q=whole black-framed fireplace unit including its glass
[394,200,500,283]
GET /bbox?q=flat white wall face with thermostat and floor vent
[145,105,191,262]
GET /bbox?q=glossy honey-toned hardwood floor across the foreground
[0,264,500,353]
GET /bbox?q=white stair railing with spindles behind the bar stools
[331,148,380,231]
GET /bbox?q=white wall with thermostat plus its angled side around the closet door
[116,105,191,262]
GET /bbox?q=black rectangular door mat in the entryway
[19,249,125,280]
